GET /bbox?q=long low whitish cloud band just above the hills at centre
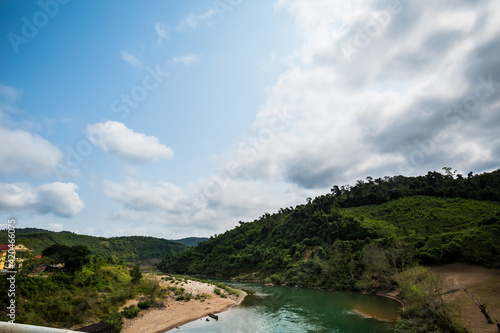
[103,175,307,238]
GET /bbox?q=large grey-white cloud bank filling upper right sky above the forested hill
[230,0,500,190]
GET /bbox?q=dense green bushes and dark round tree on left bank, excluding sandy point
[0,245,161,332]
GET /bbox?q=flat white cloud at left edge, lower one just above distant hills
[0,182,85,217]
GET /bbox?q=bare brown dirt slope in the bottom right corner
[431,264,500,333]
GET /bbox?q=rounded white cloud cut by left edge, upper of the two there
[0,126,63,176]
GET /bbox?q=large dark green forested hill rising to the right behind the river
[160,169,500,288]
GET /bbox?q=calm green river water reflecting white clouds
[172,283,400,333]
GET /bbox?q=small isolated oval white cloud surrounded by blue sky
[87,121,174,162]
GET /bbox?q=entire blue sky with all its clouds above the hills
[0,0,500,238]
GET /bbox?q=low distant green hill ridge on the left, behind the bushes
[0,228,187,262]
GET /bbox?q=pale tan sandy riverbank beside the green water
[122,274,246,333]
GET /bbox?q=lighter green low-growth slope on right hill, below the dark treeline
[341,196,500,267]
